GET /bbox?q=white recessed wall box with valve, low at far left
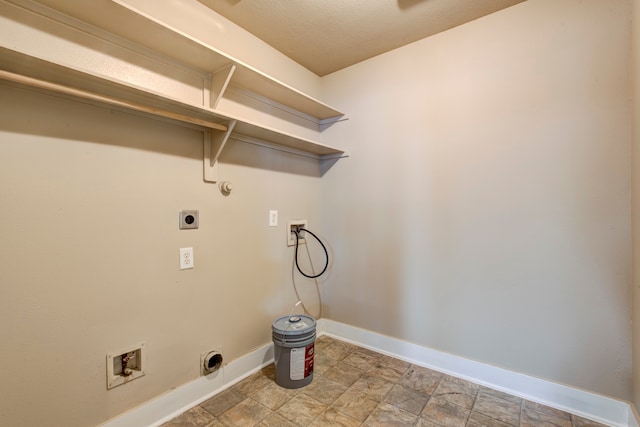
[107,342,147,390]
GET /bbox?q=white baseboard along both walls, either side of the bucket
[102,319,640,427]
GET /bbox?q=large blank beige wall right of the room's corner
[322,0,631,399]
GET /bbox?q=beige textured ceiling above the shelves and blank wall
[198,0,524,76]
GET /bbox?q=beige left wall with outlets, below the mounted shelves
[0,85,321,427]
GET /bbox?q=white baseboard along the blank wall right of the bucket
[318,319,638,427]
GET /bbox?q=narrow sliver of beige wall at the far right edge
[630,0,640,408]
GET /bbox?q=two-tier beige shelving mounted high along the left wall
[0,0,344,162]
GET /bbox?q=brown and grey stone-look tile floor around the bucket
[162,336,602,427]
